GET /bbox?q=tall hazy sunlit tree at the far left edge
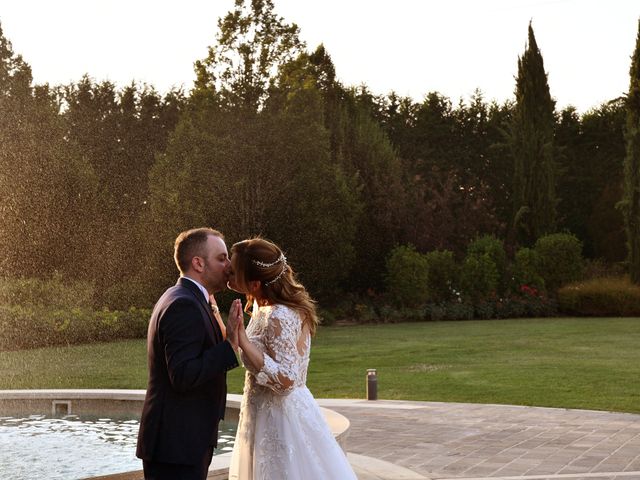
[0,24,96,277]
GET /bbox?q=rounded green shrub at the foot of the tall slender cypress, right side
[534,233,583,293]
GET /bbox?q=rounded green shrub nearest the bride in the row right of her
[387,245,429,306]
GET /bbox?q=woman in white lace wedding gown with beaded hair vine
[229,238,356,480]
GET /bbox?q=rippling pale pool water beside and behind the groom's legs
[0,415,236,480]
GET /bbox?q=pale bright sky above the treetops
[0,0,640,113]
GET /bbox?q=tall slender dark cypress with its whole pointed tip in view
[509,24,557,244]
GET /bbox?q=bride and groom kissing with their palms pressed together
[136,228,356,480]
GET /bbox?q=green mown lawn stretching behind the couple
[0,318,640,413]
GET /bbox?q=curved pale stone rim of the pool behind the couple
[0,389,351,480]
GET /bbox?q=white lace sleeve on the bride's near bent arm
[256,310,302,395]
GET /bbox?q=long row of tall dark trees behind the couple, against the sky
[0,0,636,308]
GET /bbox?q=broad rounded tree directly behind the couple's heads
[151,88,358,294]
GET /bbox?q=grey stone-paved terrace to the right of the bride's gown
[319,400,640,480]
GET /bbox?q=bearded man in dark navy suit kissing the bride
[136,228,242,480]
